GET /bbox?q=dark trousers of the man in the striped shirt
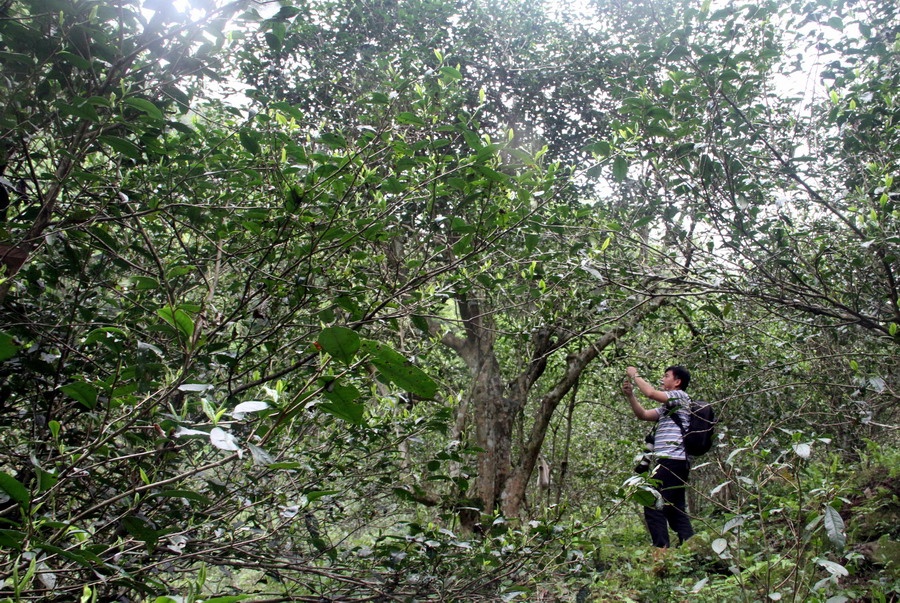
[644,459,694,548]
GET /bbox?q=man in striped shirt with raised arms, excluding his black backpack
[622,366,694,549]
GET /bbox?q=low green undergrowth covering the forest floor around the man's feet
[142,442,900,603]
